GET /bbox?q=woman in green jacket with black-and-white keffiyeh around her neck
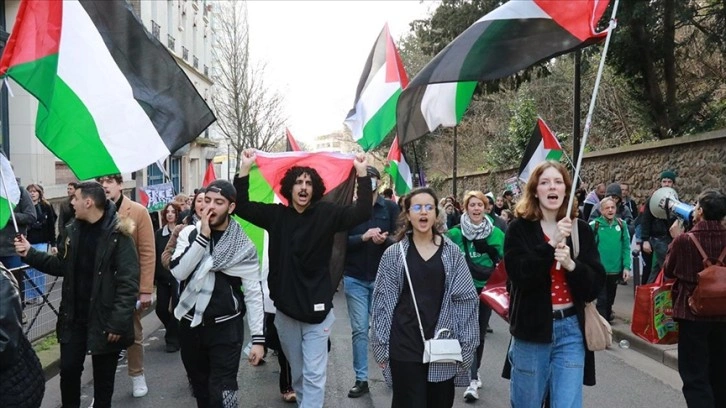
[446,191,504,402]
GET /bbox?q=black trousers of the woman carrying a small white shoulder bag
[389,359,454,408]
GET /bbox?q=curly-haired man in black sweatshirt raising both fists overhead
[235,149,372,408]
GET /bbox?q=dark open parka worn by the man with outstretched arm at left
[24,201,140,354]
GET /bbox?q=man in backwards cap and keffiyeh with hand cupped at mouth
[169,180,265,408]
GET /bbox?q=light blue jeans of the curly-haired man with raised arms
[275,310,335,408]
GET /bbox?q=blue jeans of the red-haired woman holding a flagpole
[509,316,585,408]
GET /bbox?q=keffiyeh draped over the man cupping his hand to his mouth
[174,220,261,327]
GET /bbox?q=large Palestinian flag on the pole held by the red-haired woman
[396,0,609,144]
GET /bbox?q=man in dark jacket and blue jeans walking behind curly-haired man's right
[343,166,400,398]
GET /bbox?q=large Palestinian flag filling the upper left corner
[0,0,215,180]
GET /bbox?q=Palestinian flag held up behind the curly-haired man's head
[236,151,356,288]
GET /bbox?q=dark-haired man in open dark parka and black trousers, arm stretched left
[15,181,139,408]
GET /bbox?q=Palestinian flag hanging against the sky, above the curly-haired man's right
[345,24,408,151]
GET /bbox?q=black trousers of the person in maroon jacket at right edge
[678,319,726,408]
